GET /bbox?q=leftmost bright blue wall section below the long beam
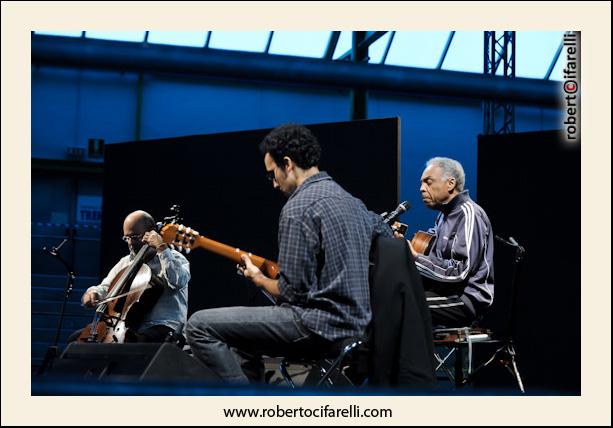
[31,68,137,159]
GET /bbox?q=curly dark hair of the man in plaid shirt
[260,123,321,169]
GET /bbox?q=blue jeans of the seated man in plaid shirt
[186,306,330,384]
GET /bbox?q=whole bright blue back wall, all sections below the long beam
[32,67,560,231]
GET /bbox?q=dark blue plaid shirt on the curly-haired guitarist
[279,172,391,340]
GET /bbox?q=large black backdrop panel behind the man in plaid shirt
[101,118,399,314]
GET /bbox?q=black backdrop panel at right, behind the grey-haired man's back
[477,131,580,393]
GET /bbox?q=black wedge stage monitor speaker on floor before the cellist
[47,343,220,383]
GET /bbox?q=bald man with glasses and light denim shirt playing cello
[79,211,190,342]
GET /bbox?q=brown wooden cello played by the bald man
[77,245,163,343]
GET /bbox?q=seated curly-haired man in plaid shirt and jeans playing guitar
[187,124,391,383]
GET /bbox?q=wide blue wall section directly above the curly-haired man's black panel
[141,78,349,139]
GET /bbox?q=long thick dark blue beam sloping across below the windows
[31,35,560,106]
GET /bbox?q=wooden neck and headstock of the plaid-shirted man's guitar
[160,223,279,279]
